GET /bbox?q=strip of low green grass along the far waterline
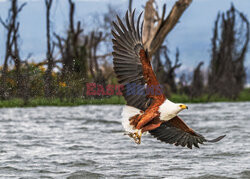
[0,88,250,108]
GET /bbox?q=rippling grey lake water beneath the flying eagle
[0,103,250,179]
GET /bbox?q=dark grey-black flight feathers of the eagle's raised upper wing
[111,10,152,110]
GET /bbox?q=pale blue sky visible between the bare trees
[0,0,250,81]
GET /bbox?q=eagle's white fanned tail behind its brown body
[122,106,141,133]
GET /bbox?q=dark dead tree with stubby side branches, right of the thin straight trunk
[54,0,87,99]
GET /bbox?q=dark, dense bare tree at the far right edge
[208,5,250,99]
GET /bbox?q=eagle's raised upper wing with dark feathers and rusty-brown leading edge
[112,11,163,111]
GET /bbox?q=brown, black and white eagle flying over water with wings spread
[112,11,225,149]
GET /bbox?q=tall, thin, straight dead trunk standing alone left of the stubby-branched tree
[44,0,54,97]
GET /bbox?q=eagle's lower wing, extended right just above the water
[149,116,226,149]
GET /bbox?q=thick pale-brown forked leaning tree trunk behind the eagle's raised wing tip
[143,0,192,56]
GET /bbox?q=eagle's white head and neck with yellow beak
[159,99,188,121]
